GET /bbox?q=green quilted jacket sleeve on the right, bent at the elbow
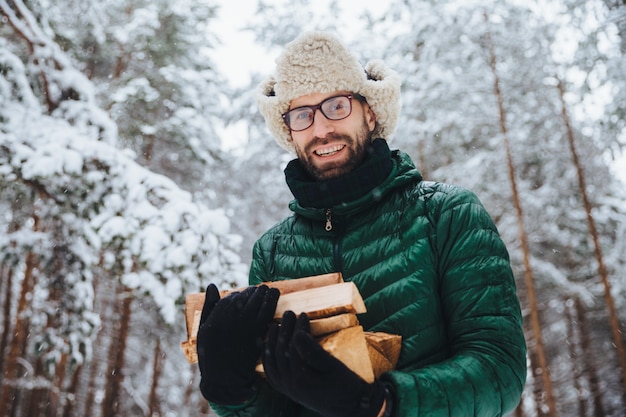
[384,188,526,417]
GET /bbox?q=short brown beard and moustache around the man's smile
[296,123,372,181]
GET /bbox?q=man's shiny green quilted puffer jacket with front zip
[214,151,526,417]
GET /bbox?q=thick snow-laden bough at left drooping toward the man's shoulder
[0,38,245,323]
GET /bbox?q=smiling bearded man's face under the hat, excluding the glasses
[289,91,376,180]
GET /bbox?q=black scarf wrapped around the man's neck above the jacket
[285,139,393,208]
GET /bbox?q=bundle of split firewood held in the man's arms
[181,273,402,382]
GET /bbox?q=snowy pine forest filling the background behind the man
[0,0,626,417]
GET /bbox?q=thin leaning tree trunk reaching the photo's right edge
[557,77,626,405]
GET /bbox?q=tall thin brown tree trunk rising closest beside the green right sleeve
[484,13,557,417]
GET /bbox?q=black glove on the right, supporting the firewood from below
[263,311,386,417]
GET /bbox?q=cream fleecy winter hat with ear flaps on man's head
[256,32,400,153]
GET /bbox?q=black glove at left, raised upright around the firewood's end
[197,284,279,405]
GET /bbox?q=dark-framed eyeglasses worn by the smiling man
[282,94,353,132]
